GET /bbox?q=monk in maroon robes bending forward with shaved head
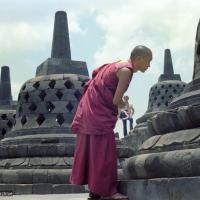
[70,45,152,200]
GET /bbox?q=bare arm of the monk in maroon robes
[113,67,132,109]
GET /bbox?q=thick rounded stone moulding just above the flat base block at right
[124,148,200,179]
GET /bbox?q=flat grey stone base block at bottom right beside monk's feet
[118,176,200,200]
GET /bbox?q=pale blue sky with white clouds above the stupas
[0,0,200,137]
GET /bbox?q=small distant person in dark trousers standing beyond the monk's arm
[120,95,134,137]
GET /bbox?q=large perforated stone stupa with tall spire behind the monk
[0,11,133,194]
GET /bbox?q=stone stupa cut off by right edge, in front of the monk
[120,18,200,200]
